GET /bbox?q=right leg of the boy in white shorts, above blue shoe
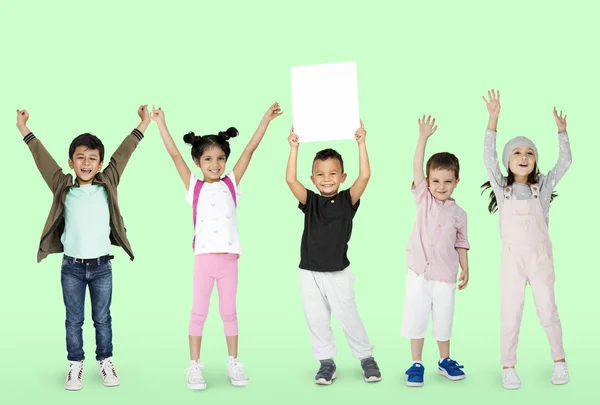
[431,281,456,360]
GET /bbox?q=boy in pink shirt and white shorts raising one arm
[401,116,470,387]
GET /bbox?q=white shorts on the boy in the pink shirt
[400,269,456,342]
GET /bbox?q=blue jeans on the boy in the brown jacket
[60,256,113,361]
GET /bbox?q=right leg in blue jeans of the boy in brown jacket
[89,262,113,360]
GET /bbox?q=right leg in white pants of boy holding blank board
[323,267,373,360]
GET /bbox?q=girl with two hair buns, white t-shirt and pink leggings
[152,103,283,390]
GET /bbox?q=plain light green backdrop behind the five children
[0,0,600,404]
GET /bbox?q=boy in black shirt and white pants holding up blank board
[286,121,381,384]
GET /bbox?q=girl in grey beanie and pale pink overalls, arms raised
[483,90,571,389]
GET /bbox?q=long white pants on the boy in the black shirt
[299,267,373,360]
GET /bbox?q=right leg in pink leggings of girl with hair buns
[215,254,238,358]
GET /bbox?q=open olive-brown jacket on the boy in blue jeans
[23,129,144,263]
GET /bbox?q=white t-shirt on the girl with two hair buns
[186,171,242,255]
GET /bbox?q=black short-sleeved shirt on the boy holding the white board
[298,190,360,272]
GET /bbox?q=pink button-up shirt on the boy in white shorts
[406,180,470,283]
